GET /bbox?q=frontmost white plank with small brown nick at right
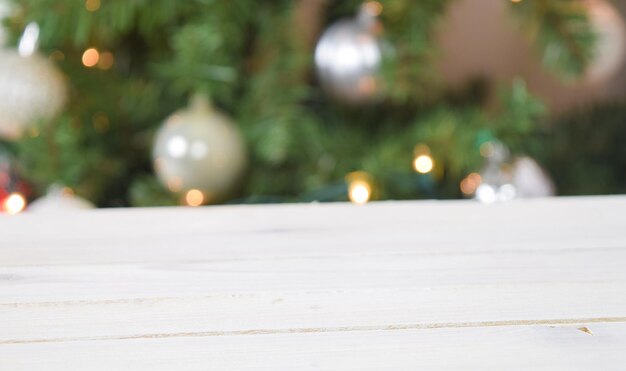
[0,323,626,371]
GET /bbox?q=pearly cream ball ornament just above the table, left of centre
[153,96,246,202]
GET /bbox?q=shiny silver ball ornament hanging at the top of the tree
[315,1,385,104]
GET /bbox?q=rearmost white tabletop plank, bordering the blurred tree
[0,196,626,266]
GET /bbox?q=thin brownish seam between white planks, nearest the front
[0,317,626,345]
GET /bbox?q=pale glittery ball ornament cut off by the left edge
[0,23,67,139]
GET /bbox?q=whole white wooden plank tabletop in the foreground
[0,196,626,370]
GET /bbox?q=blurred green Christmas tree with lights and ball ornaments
[0,0,613,206]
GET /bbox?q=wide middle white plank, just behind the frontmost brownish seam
[0,249,626,343]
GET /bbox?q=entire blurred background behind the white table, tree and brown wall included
[0,0,626,213]
